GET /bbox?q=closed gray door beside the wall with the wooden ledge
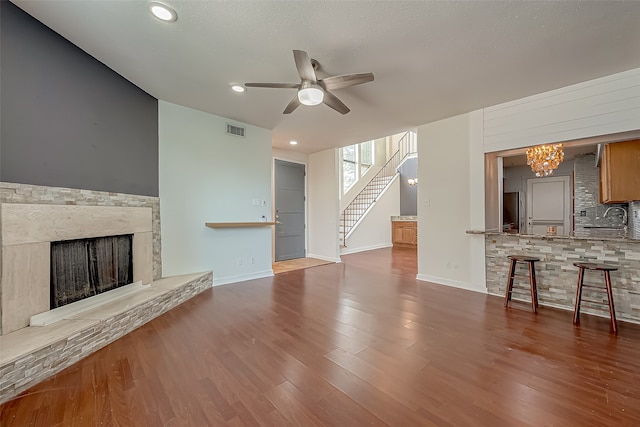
[274,159,306,261]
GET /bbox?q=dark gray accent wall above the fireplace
[0,0,158,196]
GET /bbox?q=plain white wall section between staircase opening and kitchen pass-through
[417,112,486,292]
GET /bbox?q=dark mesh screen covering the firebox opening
[51,234,133,309]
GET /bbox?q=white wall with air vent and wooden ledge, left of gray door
[158,101,273,285]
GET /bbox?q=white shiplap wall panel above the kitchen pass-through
[484,68,640,152]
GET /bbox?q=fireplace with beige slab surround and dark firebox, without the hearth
[0,203,153,334]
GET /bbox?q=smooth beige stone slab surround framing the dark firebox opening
[0,203,153,334]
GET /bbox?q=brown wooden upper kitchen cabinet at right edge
[600,139,640,203]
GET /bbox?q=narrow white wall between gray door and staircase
[307,148,340,262]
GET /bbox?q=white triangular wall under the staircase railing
[341,176,400,254]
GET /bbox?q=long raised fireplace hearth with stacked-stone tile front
[0,272,213,403]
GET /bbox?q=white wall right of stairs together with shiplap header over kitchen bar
[410,69,640,292]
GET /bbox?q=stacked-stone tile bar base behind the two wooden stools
[485,233,640,323]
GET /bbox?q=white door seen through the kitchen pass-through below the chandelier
[527,176,571,236]
